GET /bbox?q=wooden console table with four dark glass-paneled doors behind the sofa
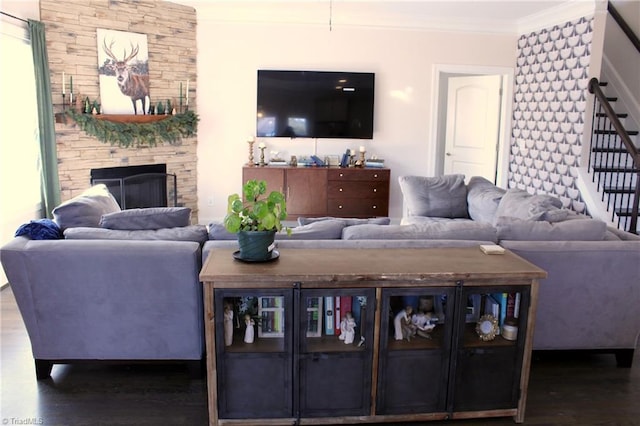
[200,247,546,425]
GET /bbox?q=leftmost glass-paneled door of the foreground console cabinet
[214,289,293,418]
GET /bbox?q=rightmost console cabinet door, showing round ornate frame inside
[450,286,530,411]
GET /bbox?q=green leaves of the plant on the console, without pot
[224,180,291,233]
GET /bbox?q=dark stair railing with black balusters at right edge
[589,78,640,234]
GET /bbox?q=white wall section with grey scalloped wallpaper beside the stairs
[508,17,593,213]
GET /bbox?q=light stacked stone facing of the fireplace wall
[40,0,197,222]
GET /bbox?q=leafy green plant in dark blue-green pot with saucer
[224,180,291,262]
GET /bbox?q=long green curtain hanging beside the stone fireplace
[29,19,60,218]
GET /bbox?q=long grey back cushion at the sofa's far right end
[496,216,607,241]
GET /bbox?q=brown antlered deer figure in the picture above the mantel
[102,39,149,114]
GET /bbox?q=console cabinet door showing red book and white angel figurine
[299,289,376,417]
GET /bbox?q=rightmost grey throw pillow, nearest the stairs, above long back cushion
[494,189,567,223]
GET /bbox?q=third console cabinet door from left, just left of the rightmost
[376,287,454,414]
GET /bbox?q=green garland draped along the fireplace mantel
[67,109,199,148]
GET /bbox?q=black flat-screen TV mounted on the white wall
[256,70,375,139]
